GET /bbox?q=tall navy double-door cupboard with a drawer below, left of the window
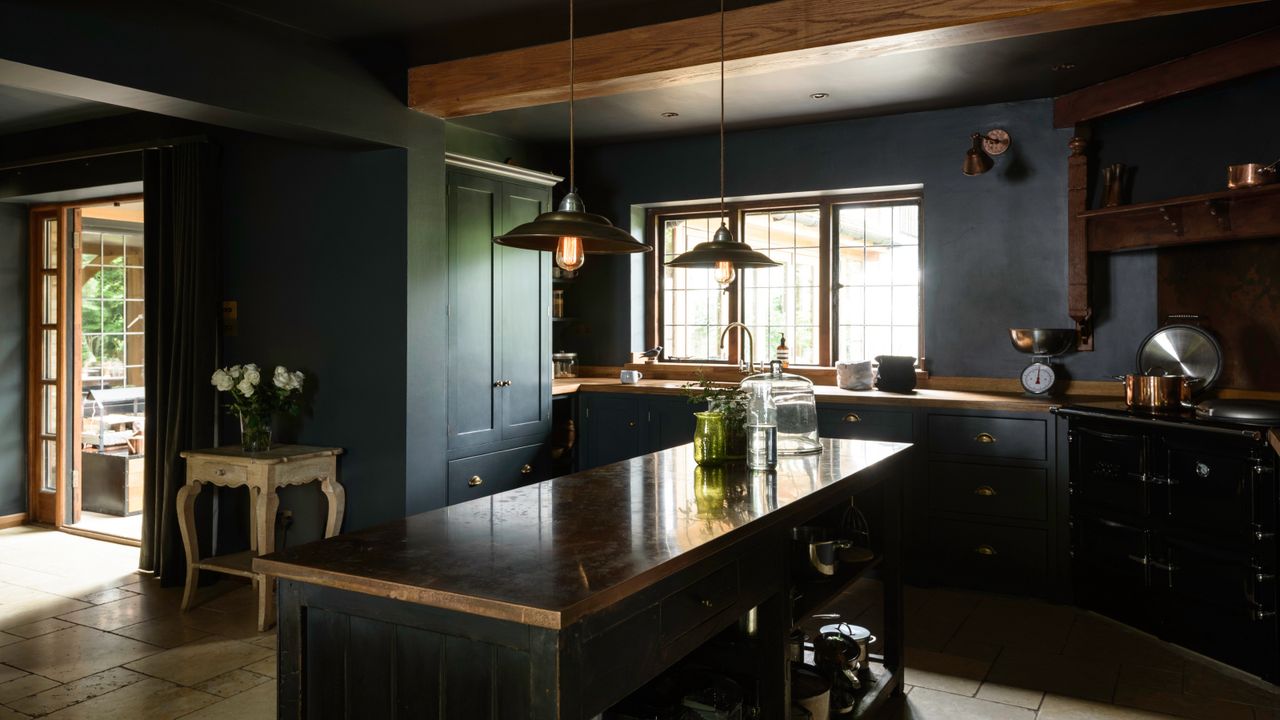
[447,163,556,503]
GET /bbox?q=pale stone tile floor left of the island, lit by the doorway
[0,527,275,720]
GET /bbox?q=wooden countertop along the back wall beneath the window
[552,378,1115,413]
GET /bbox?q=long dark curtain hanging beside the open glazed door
[141,142,219,585]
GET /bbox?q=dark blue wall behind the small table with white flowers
[218,132,407,542]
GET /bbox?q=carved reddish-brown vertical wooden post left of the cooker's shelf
[1066,133,1093,352]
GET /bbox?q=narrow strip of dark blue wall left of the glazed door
[0,202,28,516]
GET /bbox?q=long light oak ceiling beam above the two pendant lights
[408,0,1260,118]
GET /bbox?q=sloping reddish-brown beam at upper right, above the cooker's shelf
[1053,28,1280,128]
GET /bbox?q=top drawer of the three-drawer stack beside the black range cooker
[929,415,1047,460]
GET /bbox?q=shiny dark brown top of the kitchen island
[253,439,911,629]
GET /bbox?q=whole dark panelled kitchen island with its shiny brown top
[255,439,911,720]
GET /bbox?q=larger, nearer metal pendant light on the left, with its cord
[493,0,653,272]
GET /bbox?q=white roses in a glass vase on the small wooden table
[210,363,306,452]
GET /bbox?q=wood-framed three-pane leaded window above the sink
[646,193,923,366]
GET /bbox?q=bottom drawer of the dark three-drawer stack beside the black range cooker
[931,520,1048,594]
